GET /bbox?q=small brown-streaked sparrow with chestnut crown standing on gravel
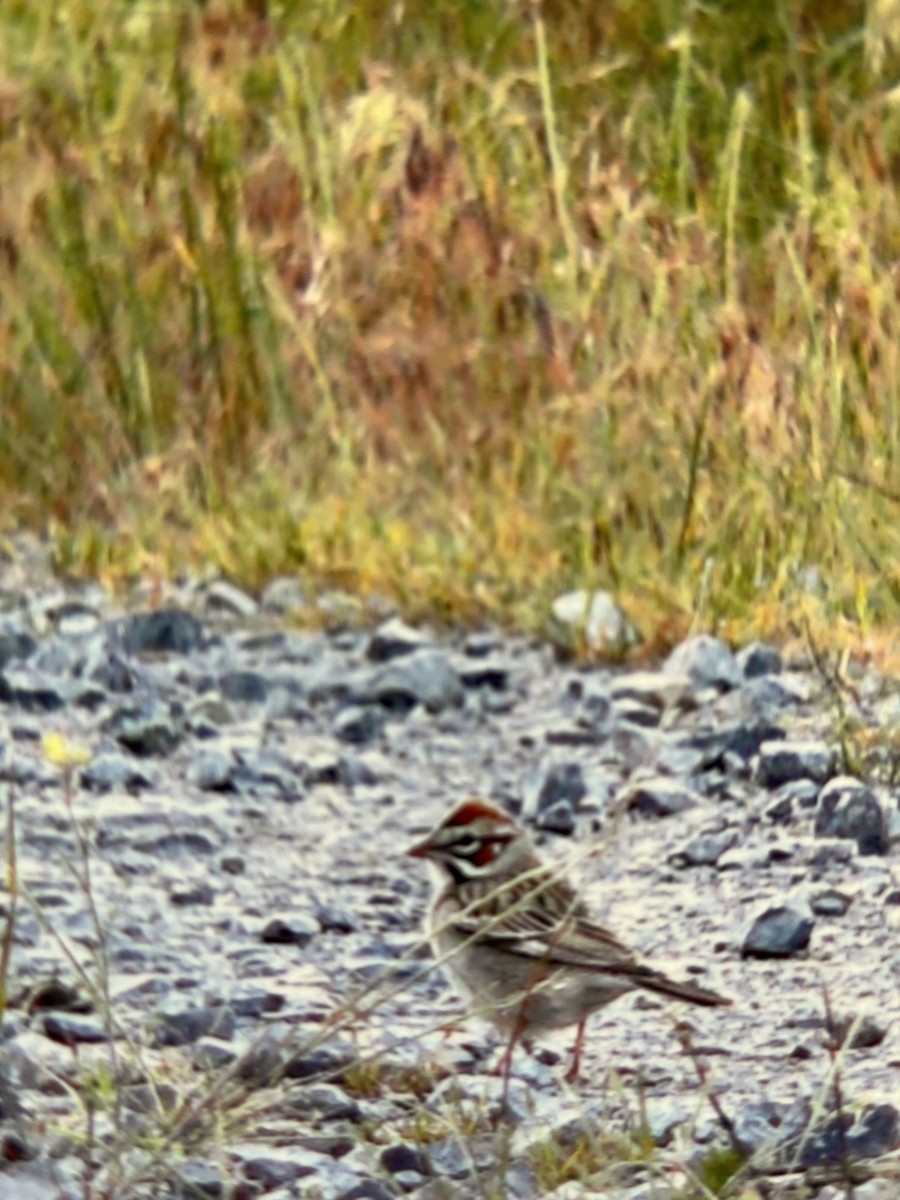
[408,800,731,1099]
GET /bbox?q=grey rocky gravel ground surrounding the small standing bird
[0,556,900,1200]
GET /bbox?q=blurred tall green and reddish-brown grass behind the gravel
[0,0,900,648]
